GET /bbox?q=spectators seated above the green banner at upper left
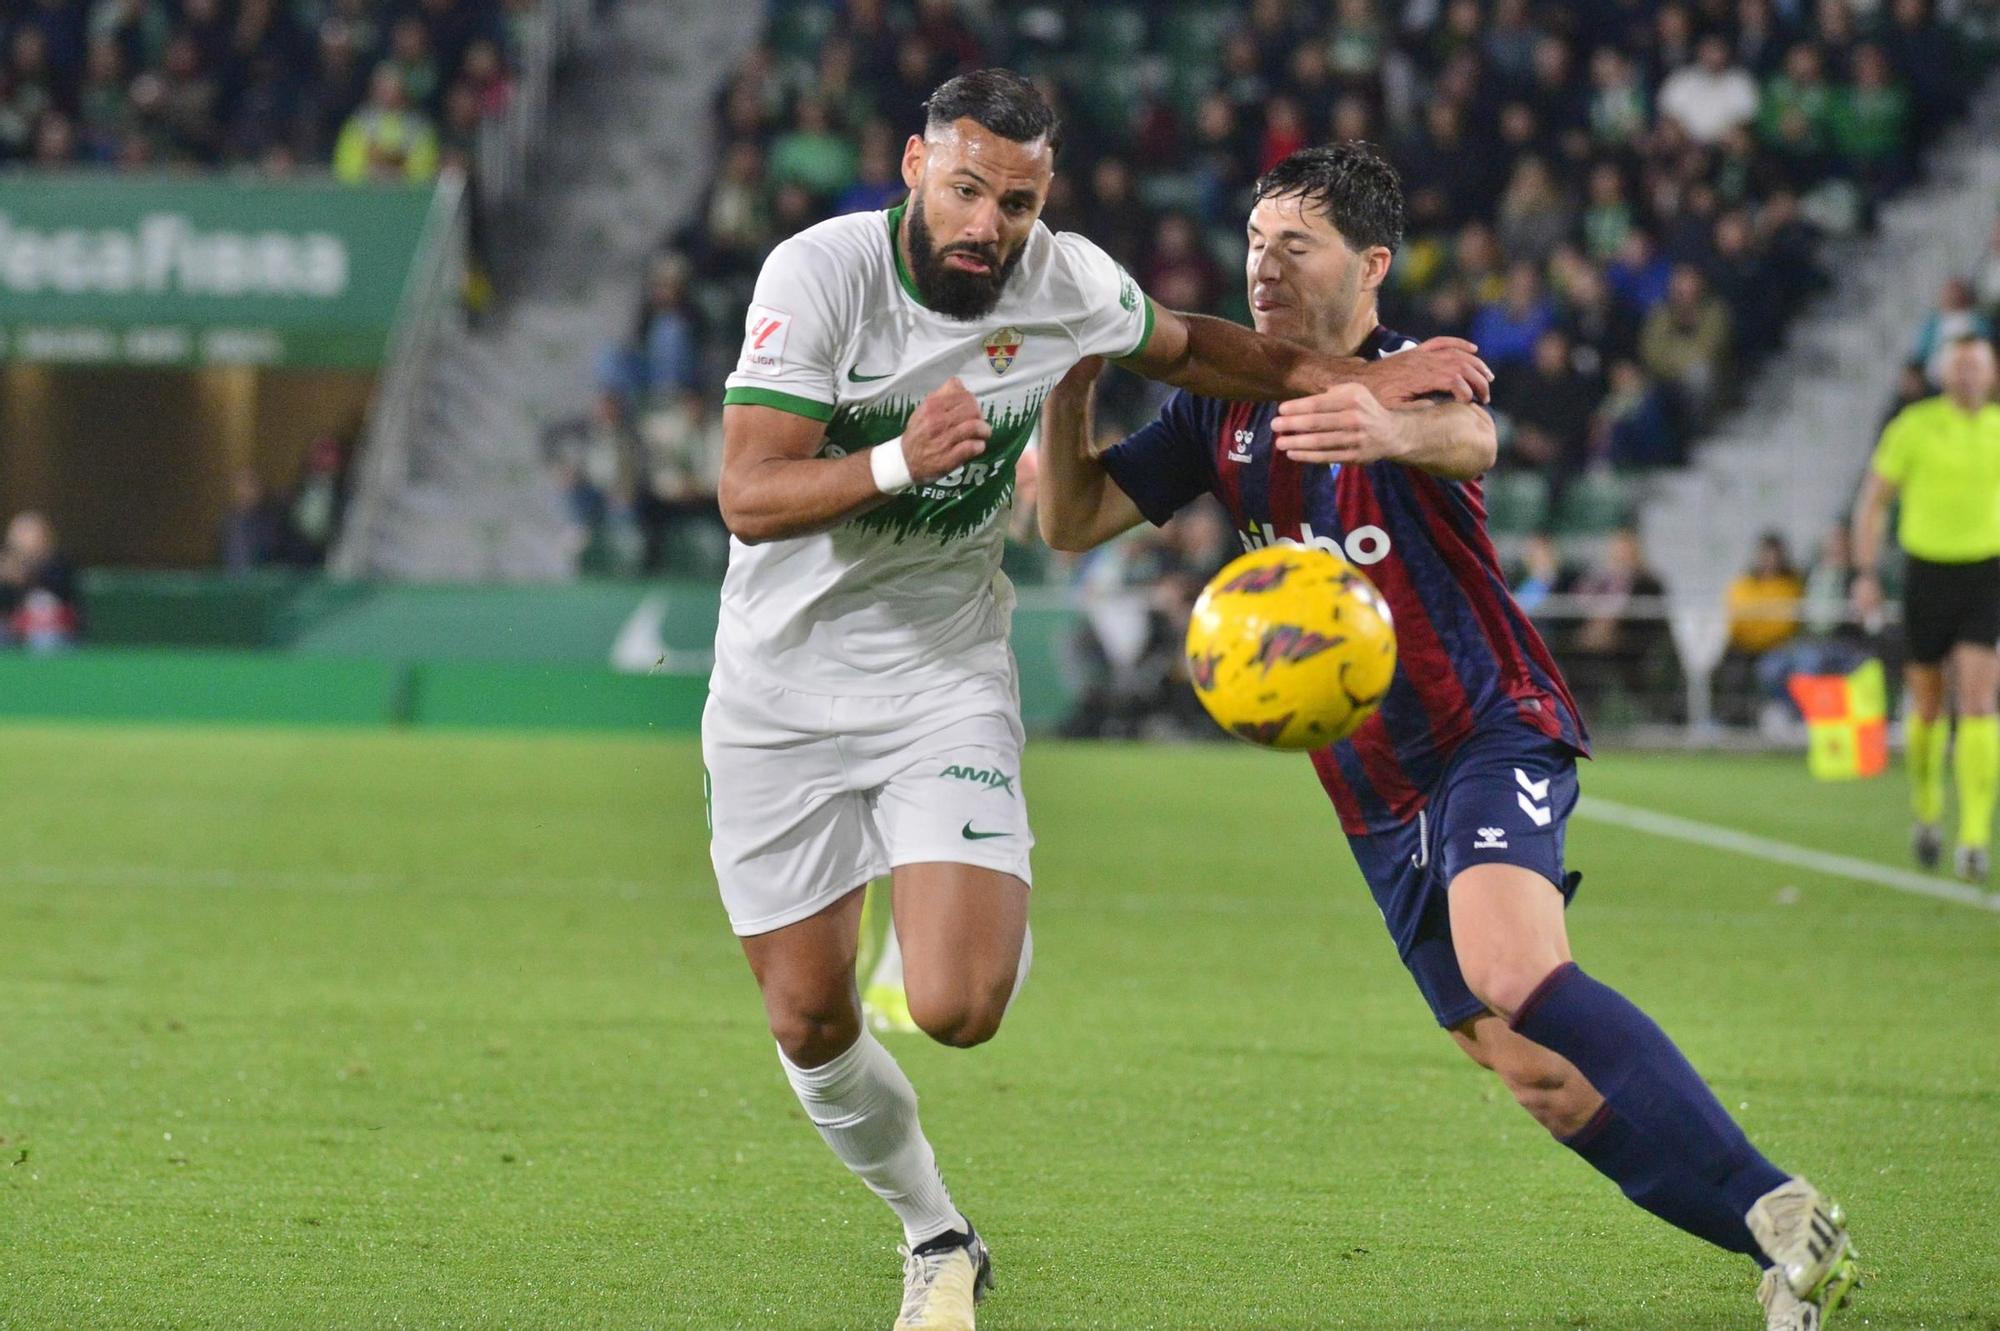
[0,0,536,182]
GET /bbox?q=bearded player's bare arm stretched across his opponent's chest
[1120,298,1494,406]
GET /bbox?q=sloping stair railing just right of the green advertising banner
[326,170,470,578]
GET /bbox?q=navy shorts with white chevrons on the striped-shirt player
[1348,721,1582,1029]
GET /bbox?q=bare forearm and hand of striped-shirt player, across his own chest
[1270,381,1500,480]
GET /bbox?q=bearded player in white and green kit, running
[702,70,1490,1329]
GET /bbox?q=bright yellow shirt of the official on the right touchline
[1874,396,2000,564]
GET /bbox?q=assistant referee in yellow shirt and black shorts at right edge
[1854,338,2000,881]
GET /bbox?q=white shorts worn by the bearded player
[702,671,1034,935]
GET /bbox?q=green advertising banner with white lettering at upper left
[0,174,432,370]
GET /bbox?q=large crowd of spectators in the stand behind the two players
[588,0,2000,575]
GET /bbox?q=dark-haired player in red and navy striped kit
[1040,144,1856,1331]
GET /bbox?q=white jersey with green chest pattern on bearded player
[716,206,1152,695]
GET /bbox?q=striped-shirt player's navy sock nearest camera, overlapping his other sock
[1512,961,1788,1215]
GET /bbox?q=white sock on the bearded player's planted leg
[778,1029,966,1247]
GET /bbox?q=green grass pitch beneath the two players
[0,725,2000,1331]
